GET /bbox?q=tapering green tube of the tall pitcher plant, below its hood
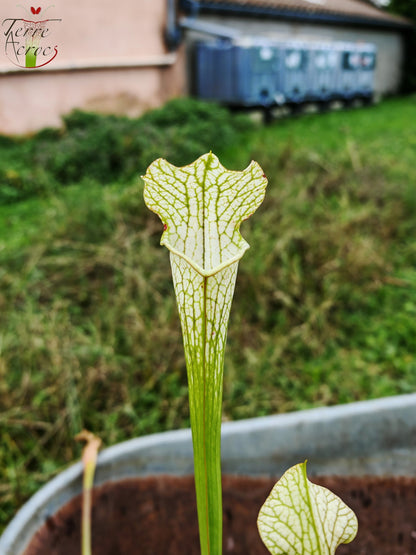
[171,254,238,555]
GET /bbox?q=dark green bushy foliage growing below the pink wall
[0,98,251,203]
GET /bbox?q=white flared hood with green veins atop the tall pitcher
[143,152,267,277]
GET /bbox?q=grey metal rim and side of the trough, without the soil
[0,394,416,555]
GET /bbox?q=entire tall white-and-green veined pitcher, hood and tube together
[143,153,267,555]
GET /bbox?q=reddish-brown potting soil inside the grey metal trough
[25,476,416,555]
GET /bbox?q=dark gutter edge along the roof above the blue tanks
[180,0,414,31]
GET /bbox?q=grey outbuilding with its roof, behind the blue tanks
[180,0,411,96]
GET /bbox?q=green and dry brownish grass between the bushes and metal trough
[0,97,416,536]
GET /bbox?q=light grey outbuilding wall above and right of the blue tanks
[187,15,404,95]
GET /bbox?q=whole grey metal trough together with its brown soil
[0,394,416,555]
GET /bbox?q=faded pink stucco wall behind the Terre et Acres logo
[0,0,185,134]
